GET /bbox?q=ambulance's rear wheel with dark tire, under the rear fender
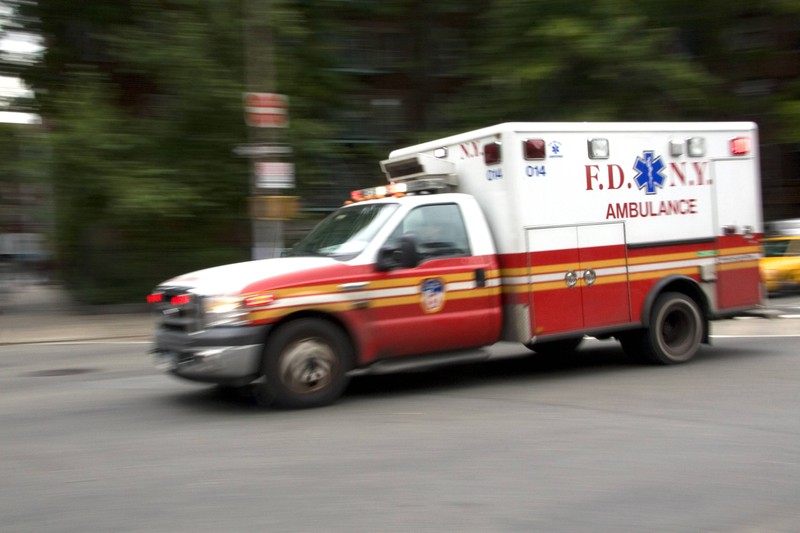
[632,292,705,365]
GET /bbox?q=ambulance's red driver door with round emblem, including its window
[370,203,500,357]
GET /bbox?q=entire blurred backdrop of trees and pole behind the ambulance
[0,0,800,304]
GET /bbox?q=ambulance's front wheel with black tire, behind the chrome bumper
[260,318,353,409]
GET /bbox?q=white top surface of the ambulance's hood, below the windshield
[160,257,339,295]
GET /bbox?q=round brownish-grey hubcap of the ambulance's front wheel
[279,338,338,394]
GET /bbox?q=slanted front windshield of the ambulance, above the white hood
[288,203,397,261]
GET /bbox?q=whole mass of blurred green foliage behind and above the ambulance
[0,0,800,302]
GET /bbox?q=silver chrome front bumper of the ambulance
[152,326,269,386]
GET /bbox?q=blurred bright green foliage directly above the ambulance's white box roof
[446,0,719,128]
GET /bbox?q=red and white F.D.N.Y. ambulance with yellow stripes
[148,122,763,408]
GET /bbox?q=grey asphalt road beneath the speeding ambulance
[0,310,800,533]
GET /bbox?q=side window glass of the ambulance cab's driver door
[389,204,470,260]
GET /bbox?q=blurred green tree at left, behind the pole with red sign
[4,0,352,303]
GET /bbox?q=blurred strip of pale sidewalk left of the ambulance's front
[0,282,155,345]
